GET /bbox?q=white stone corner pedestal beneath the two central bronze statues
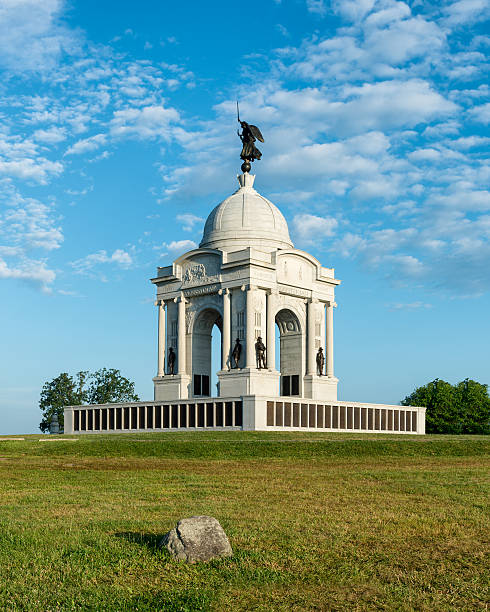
[218,368,280,397]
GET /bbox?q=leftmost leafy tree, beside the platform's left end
[39,372,87,433]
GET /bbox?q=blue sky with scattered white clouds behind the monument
[0,0,490,433]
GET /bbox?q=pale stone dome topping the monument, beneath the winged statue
[199,173,293,252]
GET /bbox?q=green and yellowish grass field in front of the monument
[0,432,490,611]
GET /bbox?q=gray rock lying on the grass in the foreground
[160,516,233,563]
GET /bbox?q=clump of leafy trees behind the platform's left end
[39,368,139,433]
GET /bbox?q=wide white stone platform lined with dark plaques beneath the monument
[64,395,426,434]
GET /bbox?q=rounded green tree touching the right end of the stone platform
[400,378,462,434]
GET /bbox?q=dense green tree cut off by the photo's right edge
[454,378,490,434]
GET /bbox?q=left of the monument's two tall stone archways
[190,306,223,397]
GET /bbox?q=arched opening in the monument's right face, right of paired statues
[276,308,304,396]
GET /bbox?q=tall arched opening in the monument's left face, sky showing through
[192,308,223,397]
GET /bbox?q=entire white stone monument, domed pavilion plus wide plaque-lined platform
[64,170,425,434]
